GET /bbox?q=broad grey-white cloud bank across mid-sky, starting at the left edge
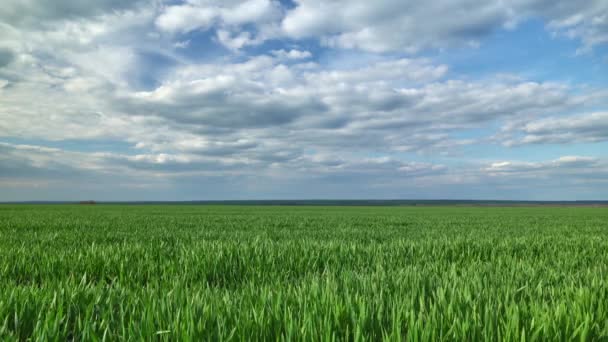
[0,46,587,162]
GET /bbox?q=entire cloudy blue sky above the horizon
[0,0,608,201]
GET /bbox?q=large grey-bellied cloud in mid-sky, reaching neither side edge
[119,57,582,136]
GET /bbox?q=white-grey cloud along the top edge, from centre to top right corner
[282,0,608,53]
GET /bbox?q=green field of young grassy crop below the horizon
[0,205,608,341]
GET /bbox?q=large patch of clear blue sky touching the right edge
[428,19,608,86]
